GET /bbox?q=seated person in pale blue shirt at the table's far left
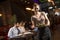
[8,23,20,40]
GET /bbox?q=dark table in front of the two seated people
[9,33,33,40]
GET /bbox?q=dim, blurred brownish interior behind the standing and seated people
[0,0,60,40]
